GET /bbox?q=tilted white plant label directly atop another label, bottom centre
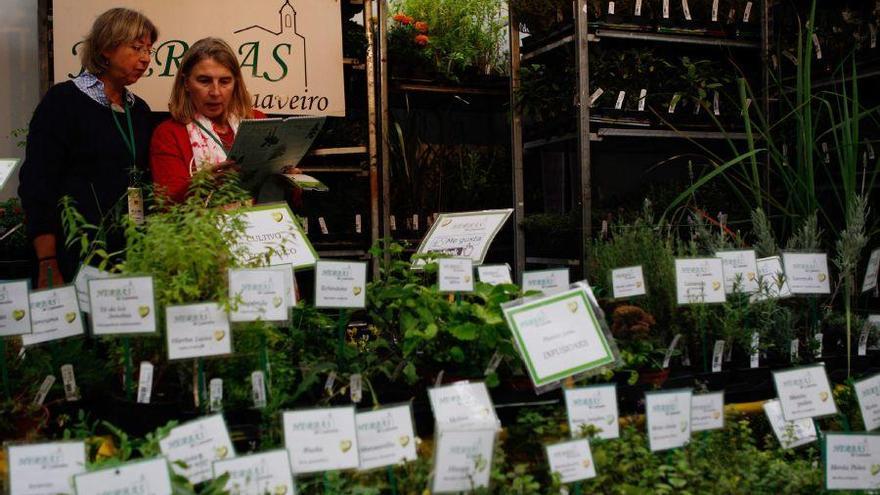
[428,382,501,430]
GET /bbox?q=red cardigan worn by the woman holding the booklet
[150,110,266,203]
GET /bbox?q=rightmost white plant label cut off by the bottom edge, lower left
[213,449,296,495]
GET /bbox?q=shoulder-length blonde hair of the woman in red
[168,38,254,124]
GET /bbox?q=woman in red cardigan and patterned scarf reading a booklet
[150,38,299,202]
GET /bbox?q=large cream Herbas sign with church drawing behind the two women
[53,0,345,116]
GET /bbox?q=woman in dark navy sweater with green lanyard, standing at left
[18,8,159,287]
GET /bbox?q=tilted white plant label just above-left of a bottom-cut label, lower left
[159,414,235,484]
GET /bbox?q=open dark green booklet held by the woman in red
[227,117,324,196]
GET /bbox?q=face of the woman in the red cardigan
[184,58,235,123]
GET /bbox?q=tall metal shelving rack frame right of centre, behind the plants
[509,0,772,280]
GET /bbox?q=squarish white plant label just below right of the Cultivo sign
[315,261,367,308]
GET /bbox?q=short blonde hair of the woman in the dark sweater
[80,7,159,75]
